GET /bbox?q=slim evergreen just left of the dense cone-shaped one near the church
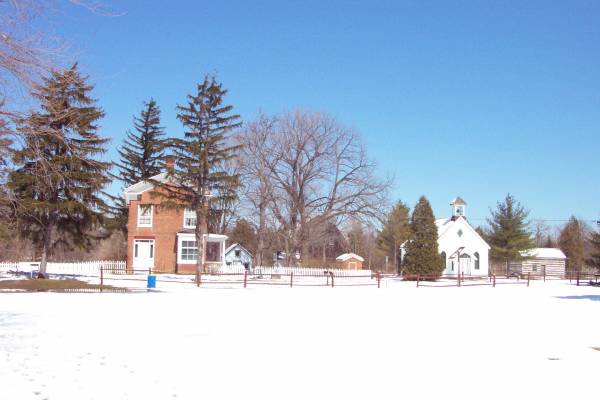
[377,201,411,273]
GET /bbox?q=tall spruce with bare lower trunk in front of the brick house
[156,75,241,271]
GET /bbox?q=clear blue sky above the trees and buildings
[45,0,600,224]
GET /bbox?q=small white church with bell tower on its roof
[400,197,490,276]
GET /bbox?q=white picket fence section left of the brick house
[0,260,127,276]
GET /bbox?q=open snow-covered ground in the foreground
[0,281,600,400]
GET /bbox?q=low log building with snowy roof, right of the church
[509,247,567,276]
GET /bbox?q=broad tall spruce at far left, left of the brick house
[8,64,110,276]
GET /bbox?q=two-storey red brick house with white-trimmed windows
[124,172,227,273]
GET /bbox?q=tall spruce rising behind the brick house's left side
[110,98,167,233]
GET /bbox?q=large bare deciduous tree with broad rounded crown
[242,111,390,264]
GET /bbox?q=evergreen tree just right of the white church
[486,194,534,272]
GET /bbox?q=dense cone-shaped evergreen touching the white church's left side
[402,196,444,278]
